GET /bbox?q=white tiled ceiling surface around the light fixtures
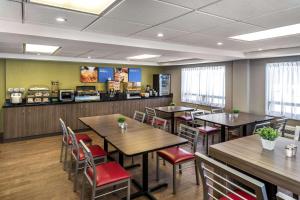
[0,0,300,65]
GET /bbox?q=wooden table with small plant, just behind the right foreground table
[196,113,274,142]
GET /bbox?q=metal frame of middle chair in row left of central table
[67,127,107,192]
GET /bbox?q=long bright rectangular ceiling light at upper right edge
[229,24,300,41]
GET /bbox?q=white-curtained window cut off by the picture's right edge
[266,62,300,119]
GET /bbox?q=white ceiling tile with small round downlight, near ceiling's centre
[131,26,188,40]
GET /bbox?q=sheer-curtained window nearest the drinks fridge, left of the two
[181,66,225,107]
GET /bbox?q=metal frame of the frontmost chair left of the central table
[80,141,131,200]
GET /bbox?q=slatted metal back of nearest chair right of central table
[178,124,199,153]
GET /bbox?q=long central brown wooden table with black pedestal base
[80,114,188,199]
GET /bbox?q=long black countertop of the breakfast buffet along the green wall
[2,94,173,108]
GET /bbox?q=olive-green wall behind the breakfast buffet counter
[0,59,162,133]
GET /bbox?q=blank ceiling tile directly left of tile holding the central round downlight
[86,17,149,36]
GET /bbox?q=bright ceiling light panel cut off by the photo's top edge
[30,0,116,15]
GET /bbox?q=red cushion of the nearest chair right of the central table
[157,147,195,164]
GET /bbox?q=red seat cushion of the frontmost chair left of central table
[87,162,130,187]
